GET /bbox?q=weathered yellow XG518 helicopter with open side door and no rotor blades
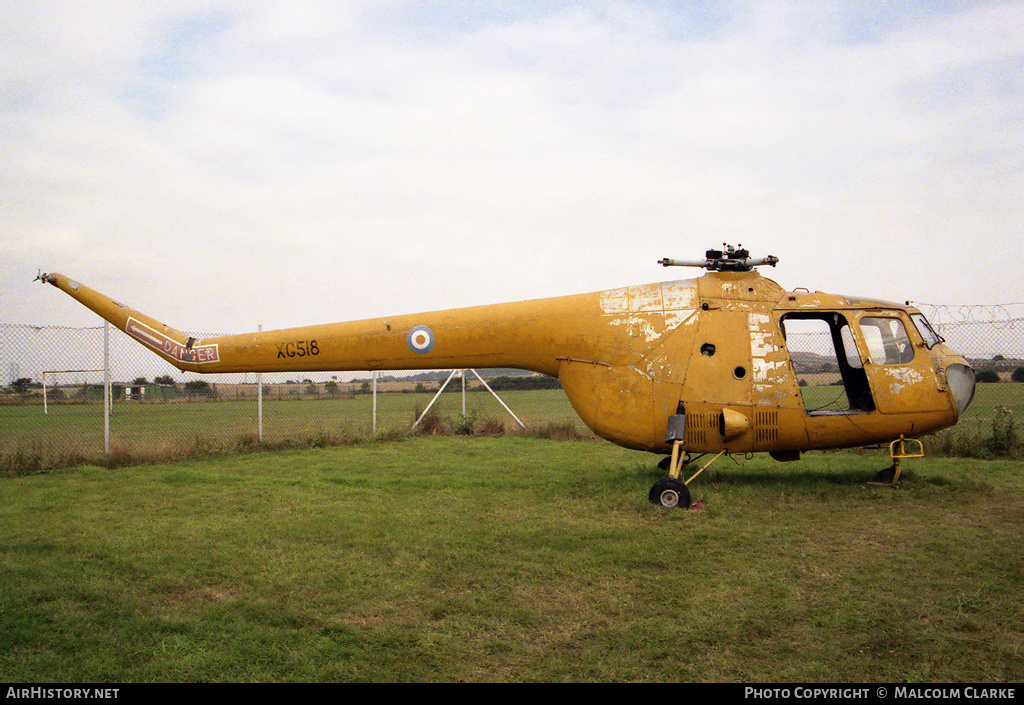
[39,246,975,507]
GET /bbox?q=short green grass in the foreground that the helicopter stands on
[0,437,1024,682]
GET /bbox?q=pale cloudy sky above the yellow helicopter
[0,0,1024,334]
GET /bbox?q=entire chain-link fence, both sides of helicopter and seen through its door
[0,304,1024,467]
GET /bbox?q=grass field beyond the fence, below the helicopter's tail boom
[0,389,586,468]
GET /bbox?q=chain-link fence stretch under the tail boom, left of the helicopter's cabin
[0,325,589,467]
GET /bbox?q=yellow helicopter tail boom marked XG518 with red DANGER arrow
[39,274,571,375]
